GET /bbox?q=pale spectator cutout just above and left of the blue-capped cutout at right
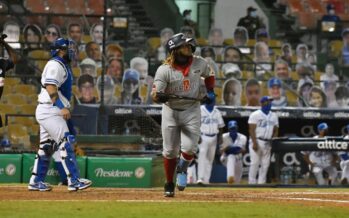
[254,42,272,80]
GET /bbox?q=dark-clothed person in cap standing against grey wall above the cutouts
[236,6,265,39]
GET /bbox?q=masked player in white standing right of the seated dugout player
[248,96,279,184]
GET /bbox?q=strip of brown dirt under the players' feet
[0,185,349,207]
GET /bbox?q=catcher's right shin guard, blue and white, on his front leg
[59,133,79,184]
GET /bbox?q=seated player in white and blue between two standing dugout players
[220,120,247,184]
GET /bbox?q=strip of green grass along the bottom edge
[0,201,349,218]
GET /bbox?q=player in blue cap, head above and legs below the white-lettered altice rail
[302,123,337,185]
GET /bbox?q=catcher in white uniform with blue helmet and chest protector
[28,38,92,191]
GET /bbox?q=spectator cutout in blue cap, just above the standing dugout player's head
[268,77,287,108]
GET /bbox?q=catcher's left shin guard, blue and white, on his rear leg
[29,141,55,184]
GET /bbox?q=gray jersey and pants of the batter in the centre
[153,56,214,159]
